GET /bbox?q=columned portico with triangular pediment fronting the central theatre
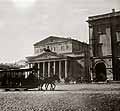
[27,52,70,80]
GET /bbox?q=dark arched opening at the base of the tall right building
[95,63,107,82]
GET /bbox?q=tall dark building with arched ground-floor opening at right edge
[88,9,120,81]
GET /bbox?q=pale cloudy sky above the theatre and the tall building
[0,0,120,63]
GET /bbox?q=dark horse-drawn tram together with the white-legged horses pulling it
[0,68,59,90]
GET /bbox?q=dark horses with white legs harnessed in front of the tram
[39,75,60,90]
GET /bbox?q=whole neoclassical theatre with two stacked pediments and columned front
[26,36,90,81]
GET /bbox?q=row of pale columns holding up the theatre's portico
[29,60,68,79]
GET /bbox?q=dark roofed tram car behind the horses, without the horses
[0,68,39,90]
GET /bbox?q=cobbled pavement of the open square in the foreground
[0,84,120,111]
